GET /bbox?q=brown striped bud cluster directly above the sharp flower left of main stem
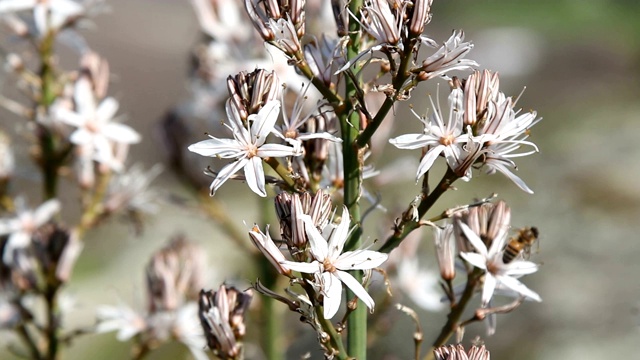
[227,69,281,122]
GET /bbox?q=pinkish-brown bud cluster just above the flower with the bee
[454,200,511,252]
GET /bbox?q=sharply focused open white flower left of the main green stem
[189,100,301,197]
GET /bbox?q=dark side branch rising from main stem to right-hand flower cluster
[378,168,459,253]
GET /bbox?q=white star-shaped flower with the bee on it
[459,222,542,307]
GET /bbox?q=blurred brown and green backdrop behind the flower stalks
[0,0,640,360]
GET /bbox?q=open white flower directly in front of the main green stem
[282,207,388,319]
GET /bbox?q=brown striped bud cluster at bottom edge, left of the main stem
[198,284,253,359]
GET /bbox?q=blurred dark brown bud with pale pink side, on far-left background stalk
[32,223,83,283]
